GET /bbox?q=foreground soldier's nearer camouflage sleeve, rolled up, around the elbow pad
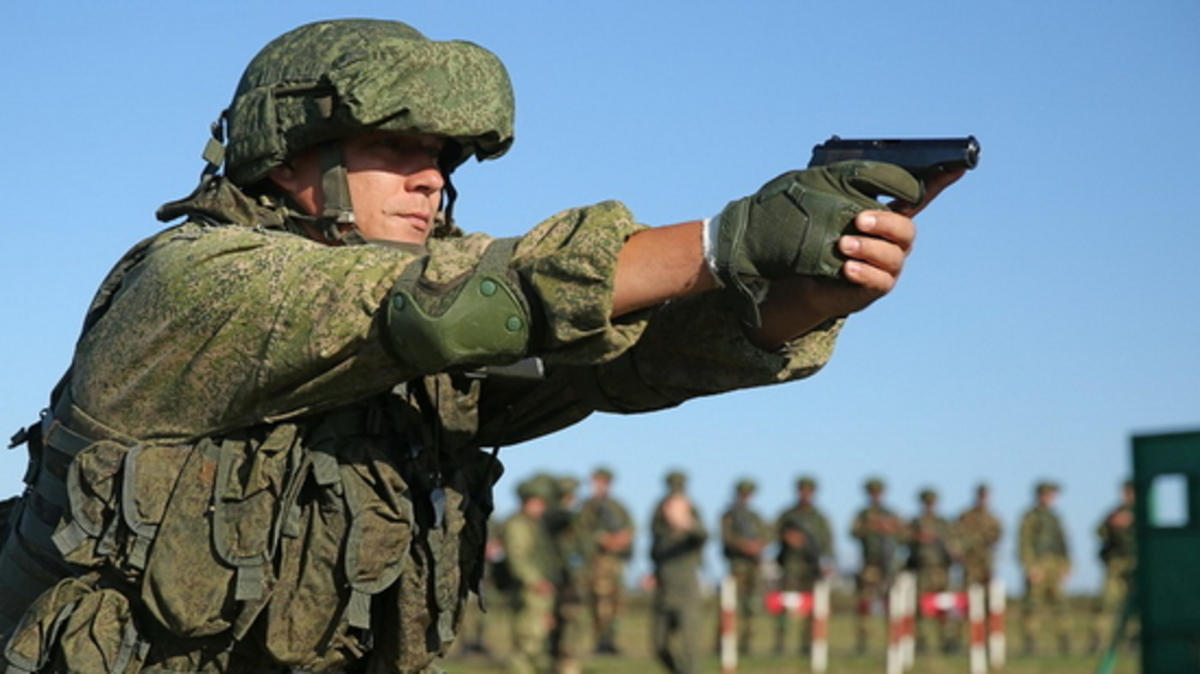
[72,203,646,439]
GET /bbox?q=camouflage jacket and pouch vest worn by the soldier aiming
[0,179,840,670]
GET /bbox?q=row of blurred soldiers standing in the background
[482,468,1135,674]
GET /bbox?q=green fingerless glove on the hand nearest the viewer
[712,161,922,326]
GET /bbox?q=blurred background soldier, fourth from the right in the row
[907,489,958,652]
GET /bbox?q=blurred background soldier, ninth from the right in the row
[578,468,634,655]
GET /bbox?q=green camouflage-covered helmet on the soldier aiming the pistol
[223,19,515,186]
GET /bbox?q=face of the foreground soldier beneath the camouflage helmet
[271,132,445,243]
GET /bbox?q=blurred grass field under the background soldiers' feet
[440,592,1140,674]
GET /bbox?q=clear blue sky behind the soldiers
[0,0,1200,590]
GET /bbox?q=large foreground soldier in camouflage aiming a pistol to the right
[0,19,961,672]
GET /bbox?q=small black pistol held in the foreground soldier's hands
[809,136,979,181]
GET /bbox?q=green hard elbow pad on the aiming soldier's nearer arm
[384,239,530,374]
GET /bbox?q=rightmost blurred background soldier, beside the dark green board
[1091,480,1138,652]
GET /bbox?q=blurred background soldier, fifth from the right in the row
[850,477,904,654]
